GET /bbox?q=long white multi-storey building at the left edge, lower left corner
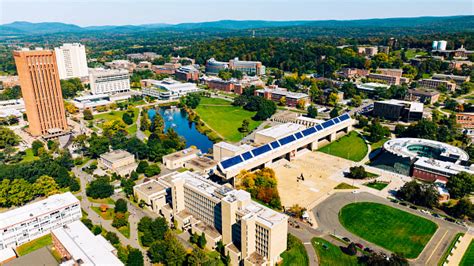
[0,192,82,250]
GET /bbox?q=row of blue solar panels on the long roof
[220,113,350,169]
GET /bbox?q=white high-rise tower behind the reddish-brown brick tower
[54,43,89,79]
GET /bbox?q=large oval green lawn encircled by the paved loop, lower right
[339,202,438,259]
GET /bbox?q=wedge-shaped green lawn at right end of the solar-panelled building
[319,131,368,162]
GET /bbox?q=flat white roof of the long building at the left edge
[0,192,79,229]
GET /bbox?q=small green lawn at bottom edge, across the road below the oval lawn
[311,237,358,266]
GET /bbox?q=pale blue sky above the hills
[0,0,474,26]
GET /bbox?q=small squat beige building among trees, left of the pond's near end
[99,150,138,176]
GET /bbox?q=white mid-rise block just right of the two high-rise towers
[89,68,130,95]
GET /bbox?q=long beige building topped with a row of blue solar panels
[218,113,354,179]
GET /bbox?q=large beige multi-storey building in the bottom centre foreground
[134,171,288,265]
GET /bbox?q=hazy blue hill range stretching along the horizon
[0,16,474,36]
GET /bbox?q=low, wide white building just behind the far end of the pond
[142,78,201,100]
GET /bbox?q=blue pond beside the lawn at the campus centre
[148,107,213,153]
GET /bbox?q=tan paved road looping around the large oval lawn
[313,192,467,265]
